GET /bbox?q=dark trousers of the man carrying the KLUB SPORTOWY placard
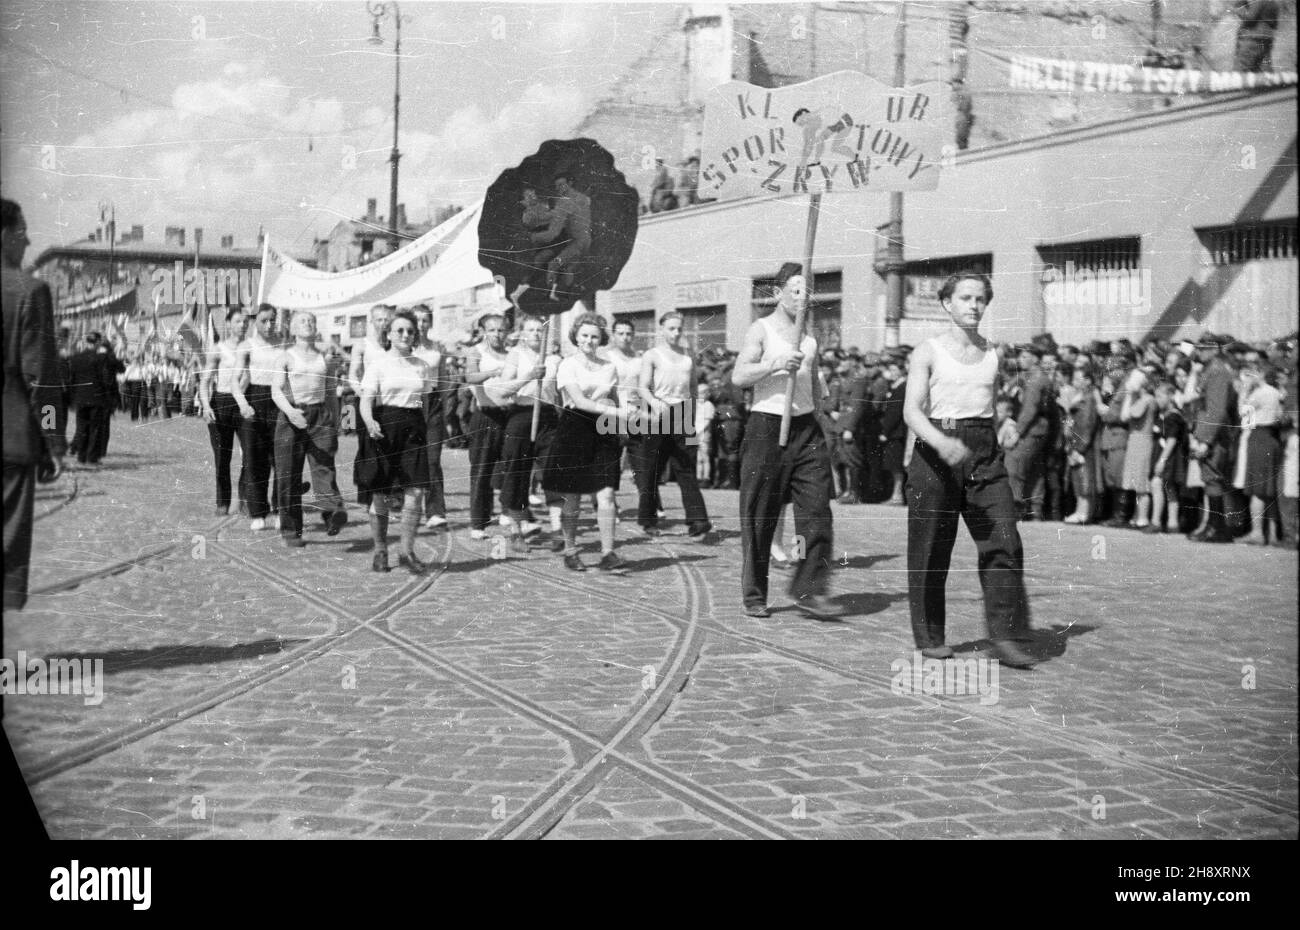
[740,412,835,607]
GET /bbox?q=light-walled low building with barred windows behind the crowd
[597,88,1300,350]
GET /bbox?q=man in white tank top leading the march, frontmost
[904,272,1035,669]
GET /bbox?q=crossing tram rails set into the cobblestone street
[20,509,1294,838]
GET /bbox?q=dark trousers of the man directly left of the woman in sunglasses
[276,403,346,536]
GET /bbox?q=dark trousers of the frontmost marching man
[907,420,1030,649]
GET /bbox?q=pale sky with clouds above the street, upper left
[0,0,681,261]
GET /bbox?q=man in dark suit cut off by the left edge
[0,200,64,610]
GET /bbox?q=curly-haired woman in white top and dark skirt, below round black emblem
[542,313,631,572]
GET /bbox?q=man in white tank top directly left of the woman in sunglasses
[270,311,347,549]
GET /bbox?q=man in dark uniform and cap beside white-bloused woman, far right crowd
[1190,333,1239,542]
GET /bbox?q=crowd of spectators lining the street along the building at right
[660,327,1300,549]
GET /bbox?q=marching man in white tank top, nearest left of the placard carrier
[636,311,714,541]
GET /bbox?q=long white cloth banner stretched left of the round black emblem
[261,200,493,313]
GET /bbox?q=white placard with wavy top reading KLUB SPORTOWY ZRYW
[699,72,950,200]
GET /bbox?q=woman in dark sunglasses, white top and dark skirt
[355,310,434,575]
